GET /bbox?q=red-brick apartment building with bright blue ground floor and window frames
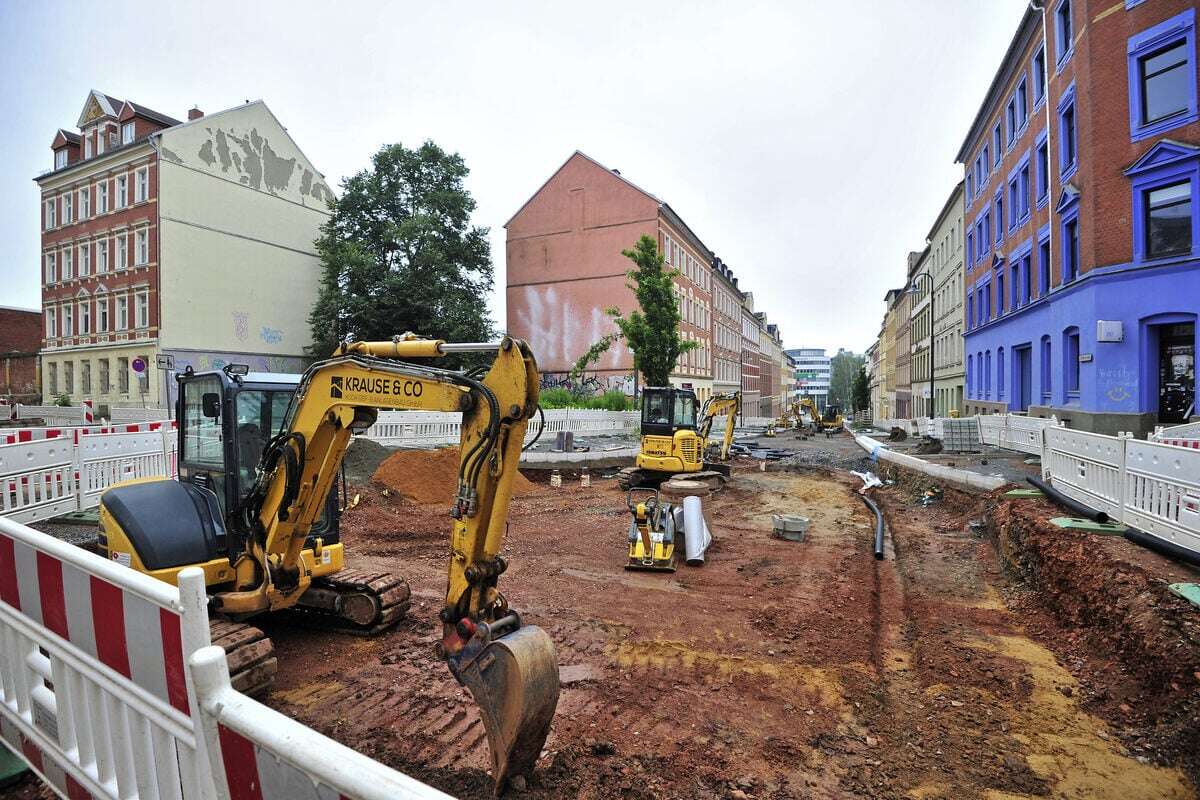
[958,0,1200,433]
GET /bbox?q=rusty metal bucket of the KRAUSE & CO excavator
[451,625,558,796]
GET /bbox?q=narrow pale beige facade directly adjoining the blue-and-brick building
[929,182,965,416]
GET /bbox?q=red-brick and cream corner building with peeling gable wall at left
[36,91,332,413]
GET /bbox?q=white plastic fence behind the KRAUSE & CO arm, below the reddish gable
[362,408,641,447]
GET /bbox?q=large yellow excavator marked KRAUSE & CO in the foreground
[100,333,559,792]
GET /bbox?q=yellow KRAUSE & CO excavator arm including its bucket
[223,335,559,793]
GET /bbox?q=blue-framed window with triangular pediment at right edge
[1126,139,1200,263]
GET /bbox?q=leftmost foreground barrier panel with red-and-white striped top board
[0,519,215,800]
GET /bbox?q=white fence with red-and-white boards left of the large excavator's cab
[0,422,178,522]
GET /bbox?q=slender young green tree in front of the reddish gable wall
[571,236,700,386]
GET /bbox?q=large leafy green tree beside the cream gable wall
[308,142,493,357]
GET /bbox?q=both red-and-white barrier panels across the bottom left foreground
[0,518,448,800]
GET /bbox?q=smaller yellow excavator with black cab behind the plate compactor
[617,386,742,492]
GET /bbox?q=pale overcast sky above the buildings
[0,0,1026,351]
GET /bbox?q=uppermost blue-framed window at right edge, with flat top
[1128,8,1200,142]
